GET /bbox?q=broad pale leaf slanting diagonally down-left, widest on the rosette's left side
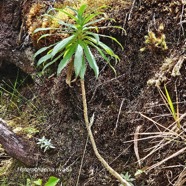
[51,35,75,57]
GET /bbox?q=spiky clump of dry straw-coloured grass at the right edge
[125,85,186,186]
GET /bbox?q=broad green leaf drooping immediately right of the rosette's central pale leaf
[83,44,99,77]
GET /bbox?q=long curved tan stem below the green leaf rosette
[80,79,131,186]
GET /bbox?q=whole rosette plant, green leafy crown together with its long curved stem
[34,5,130,186]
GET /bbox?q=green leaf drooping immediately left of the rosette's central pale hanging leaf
[57,45,76,75]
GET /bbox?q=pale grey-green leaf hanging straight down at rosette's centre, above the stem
[74,44,83,77]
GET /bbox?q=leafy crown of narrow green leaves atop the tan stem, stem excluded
[34,5,123,79]
